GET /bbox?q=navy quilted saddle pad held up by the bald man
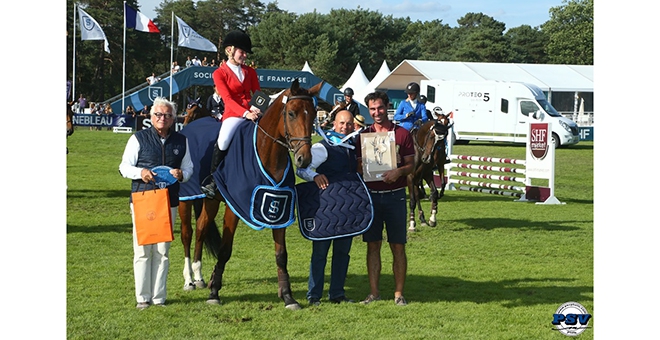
[296,173,374,241]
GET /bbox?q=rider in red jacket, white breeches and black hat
[202,30,262,199]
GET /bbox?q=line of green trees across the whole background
[67,0,594,107]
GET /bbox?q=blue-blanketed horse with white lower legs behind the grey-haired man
[178,98,220,291]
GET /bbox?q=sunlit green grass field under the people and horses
[66,127,594,339]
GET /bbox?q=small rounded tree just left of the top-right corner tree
[504,25,548,64]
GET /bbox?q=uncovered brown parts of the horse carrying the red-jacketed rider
[197,79,323,310]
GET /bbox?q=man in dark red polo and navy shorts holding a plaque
[356,91,415,306]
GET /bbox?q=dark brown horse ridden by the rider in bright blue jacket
[407,114,452,231]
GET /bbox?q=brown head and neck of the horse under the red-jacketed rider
[259,79,323,168]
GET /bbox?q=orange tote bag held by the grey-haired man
[131,188,174,246]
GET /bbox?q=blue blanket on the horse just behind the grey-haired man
[179,117,222,201]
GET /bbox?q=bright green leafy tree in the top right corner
[541,0,594,65]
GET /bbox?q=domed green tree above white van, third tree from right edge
[454,13,509,62]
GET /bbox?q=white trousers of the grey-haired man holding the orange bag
[131,203,177,304]
